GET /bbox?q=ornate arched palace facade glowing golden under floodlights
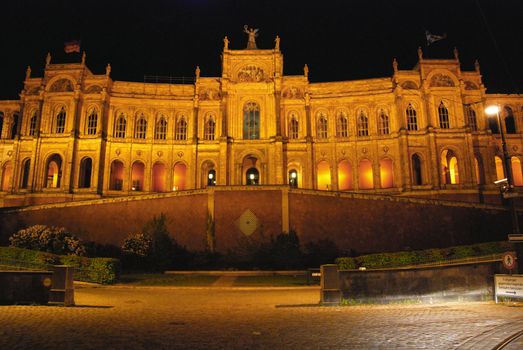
[0,38,523,206]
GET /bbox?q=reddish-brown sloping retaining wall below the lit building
[0,186,510,253]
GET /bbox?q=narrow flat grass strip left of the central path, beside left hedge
[120,273,219,287]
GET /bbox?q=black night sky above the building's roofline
[0,0,523,99]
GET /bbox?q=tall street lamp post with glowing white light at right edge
[485,105,523,274]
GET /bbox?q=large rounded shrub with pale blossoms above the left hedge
[9,225,85,255]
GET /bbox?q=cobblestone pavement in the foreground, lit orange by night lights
[0,287,523,350]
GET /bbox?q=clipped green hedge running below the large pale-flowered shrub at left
[0,247,120,284]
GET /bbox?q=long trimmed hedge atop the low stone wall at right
[336,242,513,270]
